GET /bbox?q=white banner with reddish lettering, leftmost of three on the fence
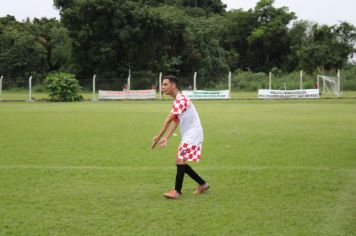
[99,89,156,100]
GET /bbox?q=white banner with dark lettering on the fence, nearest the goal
[258,89,319,99]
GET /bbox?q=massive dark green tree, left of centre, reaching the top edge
[55,0,184,77]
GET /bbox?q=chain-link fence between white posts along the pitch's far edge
[0,71,356,101]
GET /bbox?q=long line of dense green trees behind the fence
[0,0,356,85]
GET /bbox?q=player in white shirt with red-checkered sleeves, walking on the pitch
[151,75,210,199]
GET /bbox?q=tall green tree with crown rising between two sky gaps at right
[222,0,295,71]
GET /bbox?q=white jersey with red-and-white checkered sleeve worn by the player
[171,93,204,144]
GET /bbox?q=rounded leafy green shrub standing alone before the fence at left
[45,72,83,102]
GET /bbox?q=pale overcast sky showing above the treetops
[0,0,356,25]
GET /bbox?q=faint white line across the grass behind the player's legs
[0,165,356,172]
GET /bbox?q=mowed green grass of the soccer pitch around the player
[0,99,356,235]
